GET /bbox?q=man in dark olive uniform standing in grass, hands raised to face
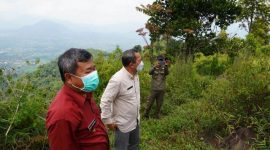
[144,55,169,118]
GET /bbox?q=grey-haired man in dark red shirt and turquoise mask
[46,48,109,150]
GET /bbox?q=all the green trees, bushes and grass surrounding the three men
[0,0,270,150]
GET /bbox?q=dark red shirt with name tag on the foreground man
[46,85,109,150]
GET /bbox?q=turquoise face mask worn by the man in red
[72,70,99,92]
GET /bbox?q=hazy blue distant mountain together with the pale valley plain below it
[0,20,146,71]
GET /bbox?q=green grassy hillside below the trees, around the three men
[0,43,270,150]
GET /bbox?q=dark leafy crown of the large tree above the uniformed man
[137,0,241,55]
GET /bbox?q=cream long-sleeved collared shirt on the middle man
[100,67,140,133]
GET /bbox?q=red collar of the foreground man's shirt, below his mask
[62,84,93,108]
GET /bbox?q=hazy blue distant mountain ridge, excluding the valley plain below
[0,20,142,51]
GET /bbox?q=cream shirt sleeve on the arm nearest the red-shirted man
[100,78,120,124]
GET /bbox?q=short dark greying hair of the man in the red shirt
[58,48,92,82]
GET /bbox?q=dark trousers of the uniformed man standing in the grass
[144,90,165,118]
